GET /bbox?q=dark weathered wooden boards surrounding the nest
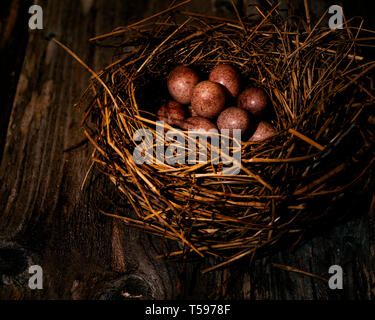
[0,0,375,300]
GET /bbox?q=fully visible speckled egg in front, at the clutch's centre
[191,81,225,118]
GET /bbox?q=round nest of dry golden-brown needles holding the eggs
[71,2,375,271]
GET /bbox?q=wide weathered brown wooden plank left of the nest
[0,1,186,298]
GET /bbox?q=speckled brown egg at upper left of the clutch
[167,66,199,104]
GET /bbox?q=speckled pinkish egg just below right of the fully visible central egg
[217,107,251,135]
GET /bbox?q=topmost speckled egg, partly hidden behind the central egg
[208,64,240,98]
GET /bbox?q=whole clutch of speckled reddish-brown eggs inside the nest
[157,64,276,142]
